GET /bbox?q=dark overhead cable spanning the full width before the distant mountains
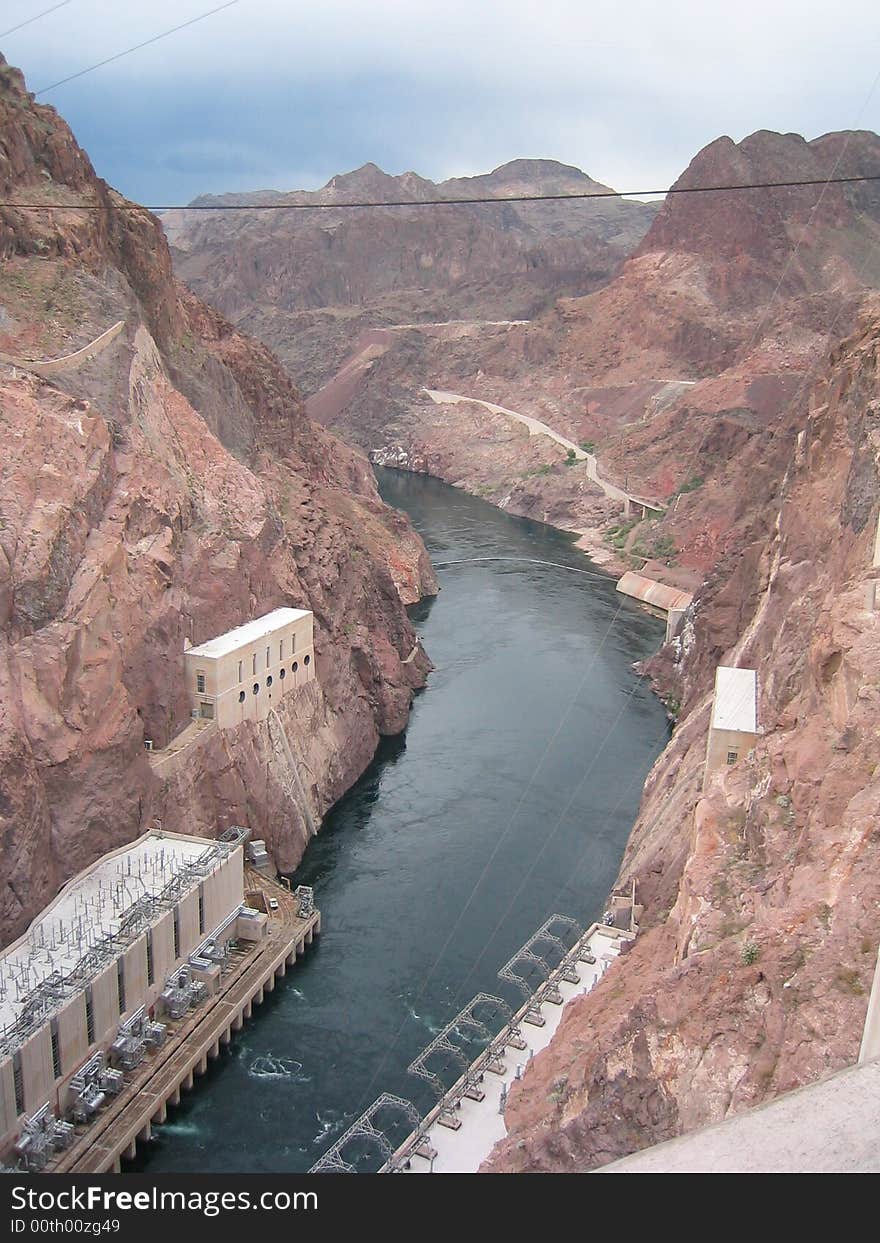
[0,172,880,211]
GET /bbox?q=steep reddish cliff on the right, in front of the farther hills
[487,302,880,1171]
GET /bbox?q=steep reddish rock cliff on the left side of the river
[0,62,436,938]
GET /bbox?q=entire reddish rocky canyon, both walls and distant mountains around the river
[0,43,880,1171]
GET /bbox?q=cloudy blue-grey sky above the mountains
[0,0,880,205]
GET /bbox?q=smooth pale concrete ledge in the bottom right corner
[595,1062,880,1173]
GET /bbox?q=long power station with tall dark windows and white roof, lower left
[0,829,266,1167]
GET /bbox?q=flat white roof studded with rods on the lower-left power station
[0,833,241,1035]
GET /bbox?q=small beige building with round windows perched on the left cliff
[184,608,314,730]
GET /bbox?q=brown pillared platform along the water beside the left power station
[46,869,321,1173]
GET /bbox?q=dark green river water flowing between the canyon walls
[129,471,667,1173]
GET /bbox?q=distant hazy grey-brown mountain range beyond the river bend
[163,160,656,394]
